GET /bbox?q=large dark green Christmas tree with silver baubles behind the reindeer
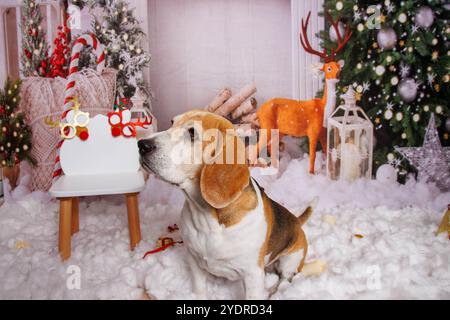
[320,0,450,178]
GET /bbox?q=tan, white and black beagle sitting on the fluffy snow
[138,110,312,299]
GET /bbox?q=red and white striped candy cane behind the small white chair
[53,34,105,182]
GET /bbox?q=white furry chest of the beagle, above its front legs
[181,188,267,280]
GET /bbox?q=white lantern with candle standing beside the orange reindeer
[327,86,373,181]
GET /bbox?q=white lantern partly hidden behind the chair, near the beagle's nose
[130,88,158,139]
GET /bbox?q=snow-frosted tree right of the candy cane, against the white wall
[72,0,150,98]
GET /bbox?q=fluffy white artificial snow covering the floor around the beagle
[0,150,450,299]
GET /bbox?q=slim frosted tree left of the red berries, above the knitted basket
[21,0,49,77]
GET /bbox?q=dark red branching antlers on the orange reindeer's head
[300,11,352,62]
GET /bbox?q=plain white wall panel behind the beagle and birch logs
[148,0,292,129]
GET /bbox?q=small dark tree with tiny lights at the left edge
[0,79,34,167]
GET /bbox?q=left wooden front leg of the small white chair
[58,198,72,260]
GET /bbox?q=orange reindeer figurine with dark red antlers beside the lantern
[257,12,352,174]
